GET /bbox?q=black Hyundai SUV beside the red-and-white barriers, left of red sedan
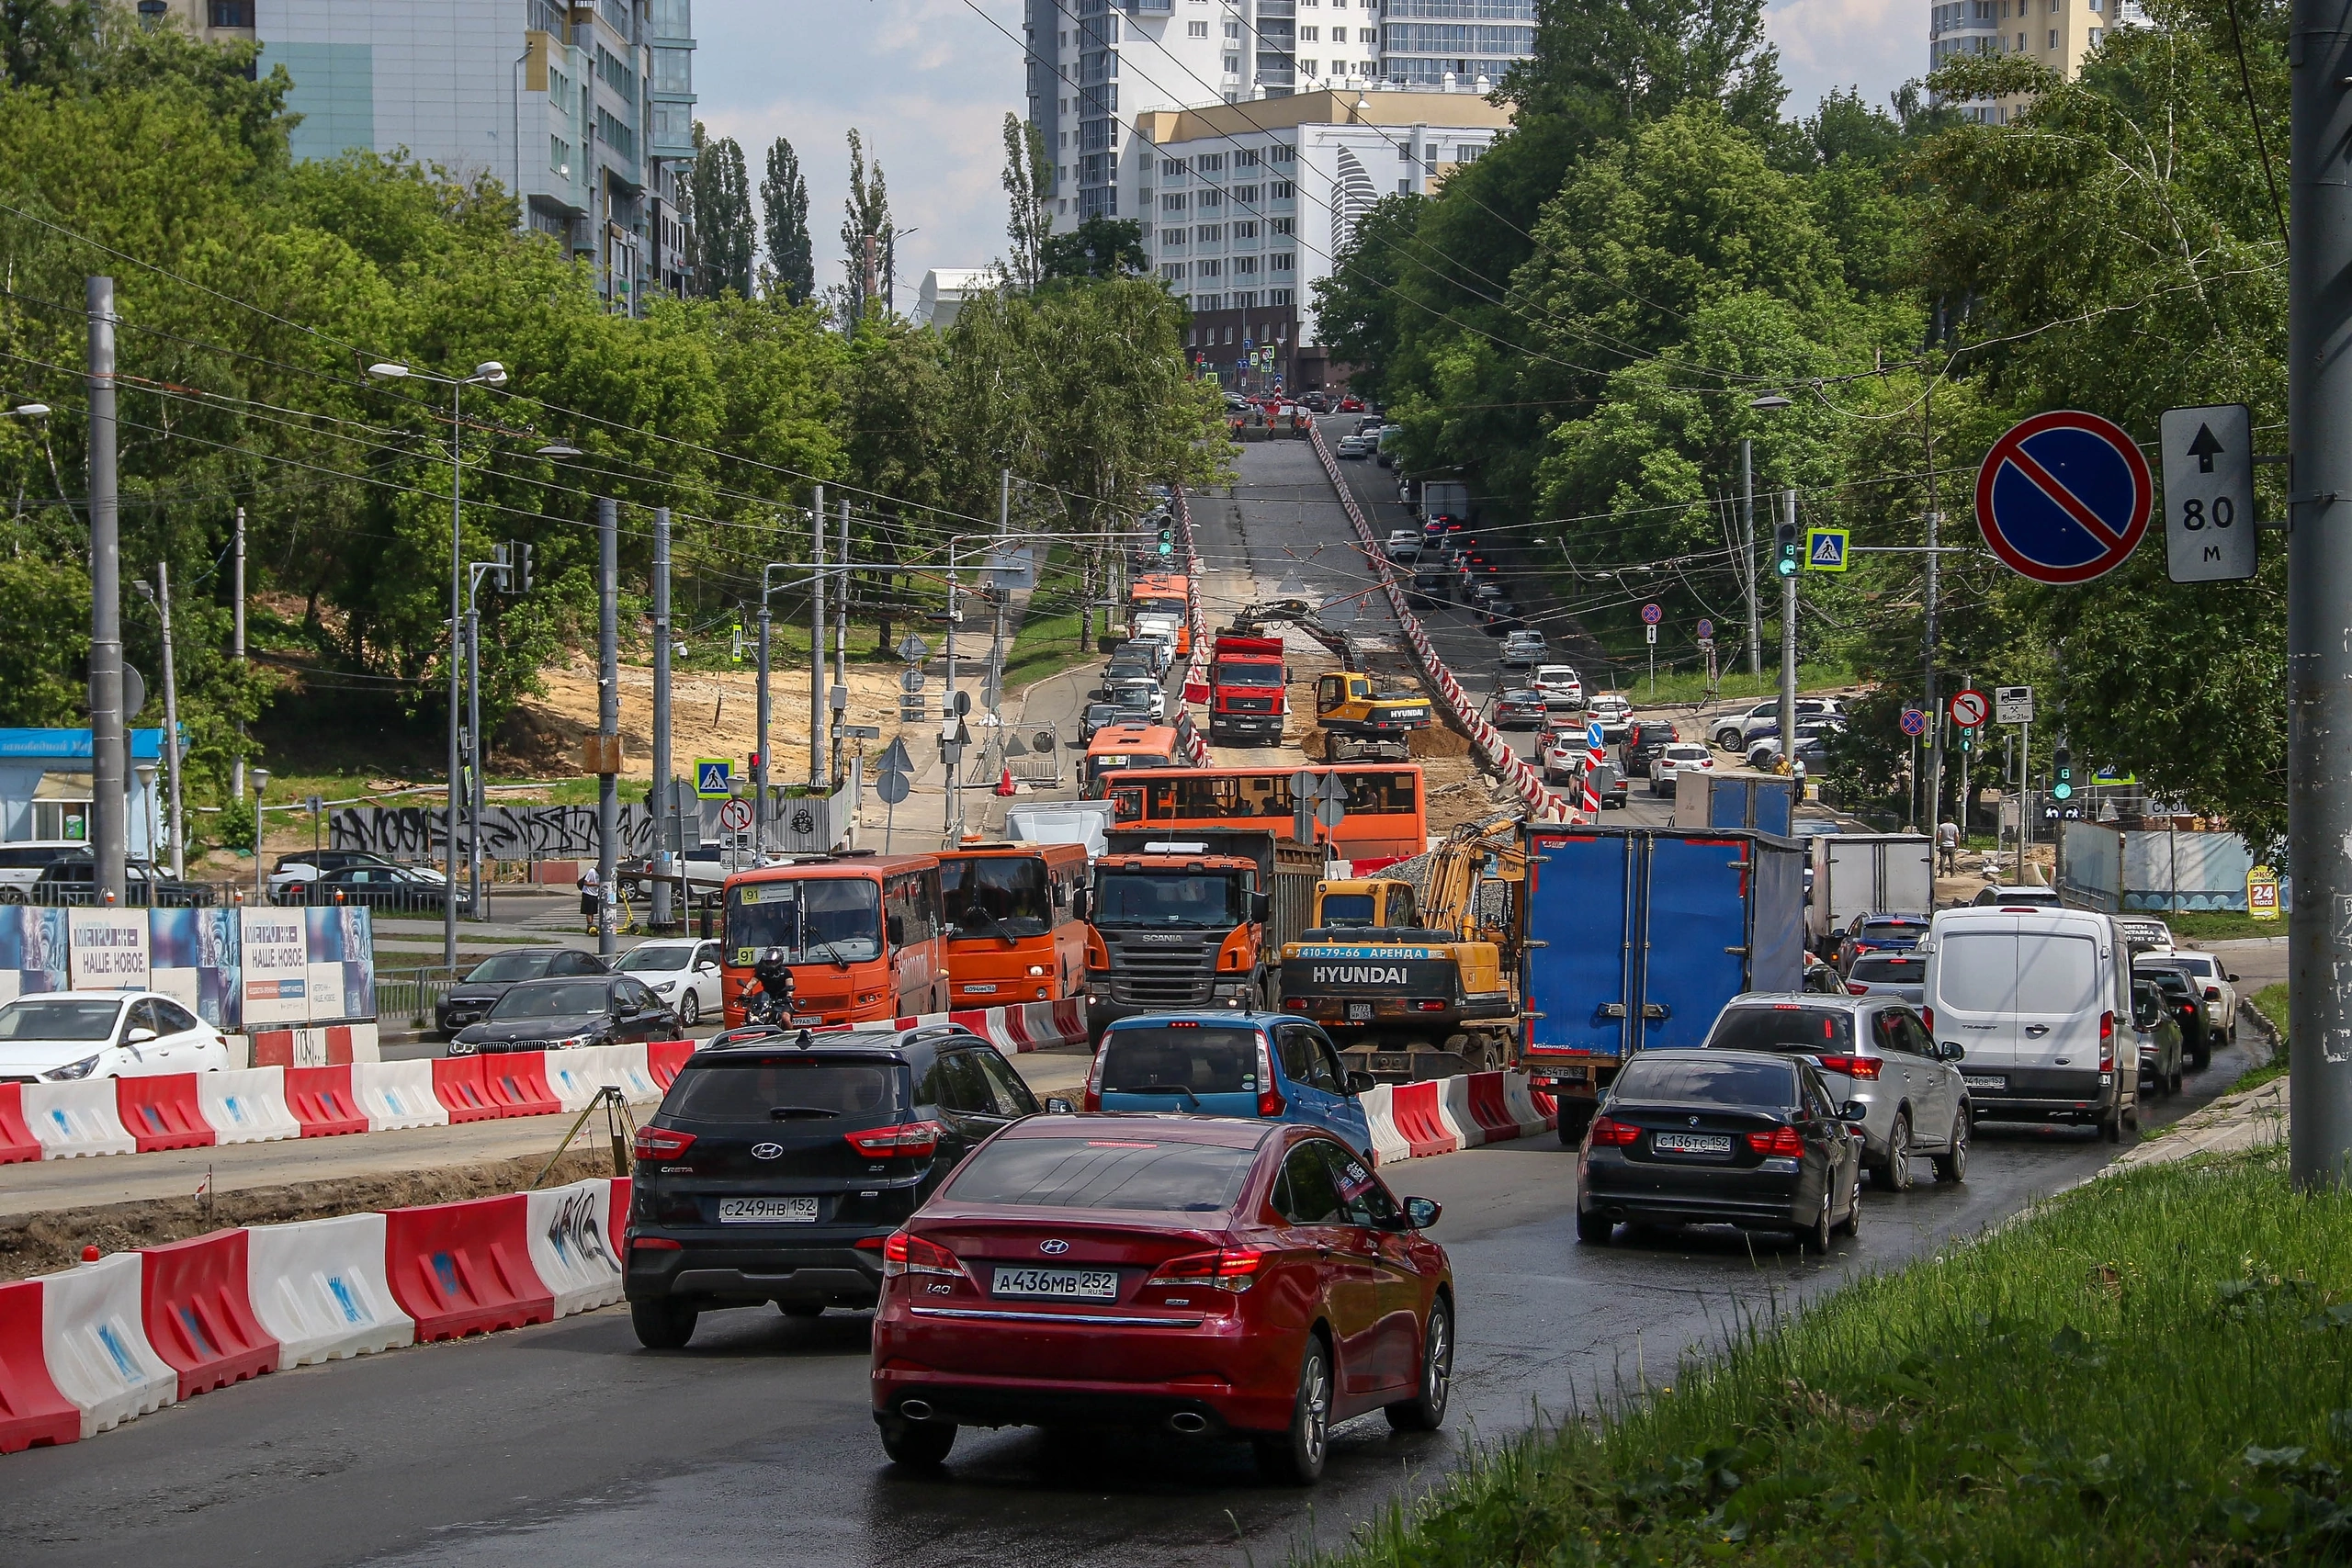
[623,1022,1037,1349]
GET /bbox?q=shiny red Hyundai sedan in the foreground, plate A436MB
[873,1114,1453,1483]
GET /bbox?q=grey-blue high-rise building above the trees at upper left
[139,0,694,315]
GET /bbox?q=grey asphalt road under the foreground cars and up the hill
[0,442,2277,1568]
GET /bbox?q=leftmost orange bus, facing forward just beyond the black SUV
[722,853,948,1027]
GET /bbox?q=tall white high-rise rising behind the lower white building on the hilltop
[1023,0,1536,221]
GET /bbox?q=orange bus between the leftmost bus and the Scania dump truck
[938,841,1087,1006]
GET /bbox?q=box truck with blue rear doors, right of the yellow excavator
[1520,823,1804,1145]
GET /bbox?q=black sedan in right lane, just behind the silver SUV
[1576,1051,1865,1253]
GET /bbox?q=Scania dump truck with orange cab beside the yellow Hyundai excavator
[1087,829,1324,1042]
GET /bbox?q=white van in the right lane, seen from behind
[1919,908,2141,1143]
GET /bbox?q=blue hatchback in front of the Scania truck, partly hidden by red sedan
[1087,1013,1371,1156]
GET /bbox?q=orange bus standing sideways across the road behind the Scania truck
[1103,761,1430,874]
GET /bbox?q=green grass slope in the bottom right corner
[1340,1152,2352,1568]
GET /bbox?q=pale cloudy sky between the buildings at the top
[694,0,1928,310]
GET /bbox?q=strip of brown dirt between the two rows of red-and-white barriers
[0,1149,612,1279]
